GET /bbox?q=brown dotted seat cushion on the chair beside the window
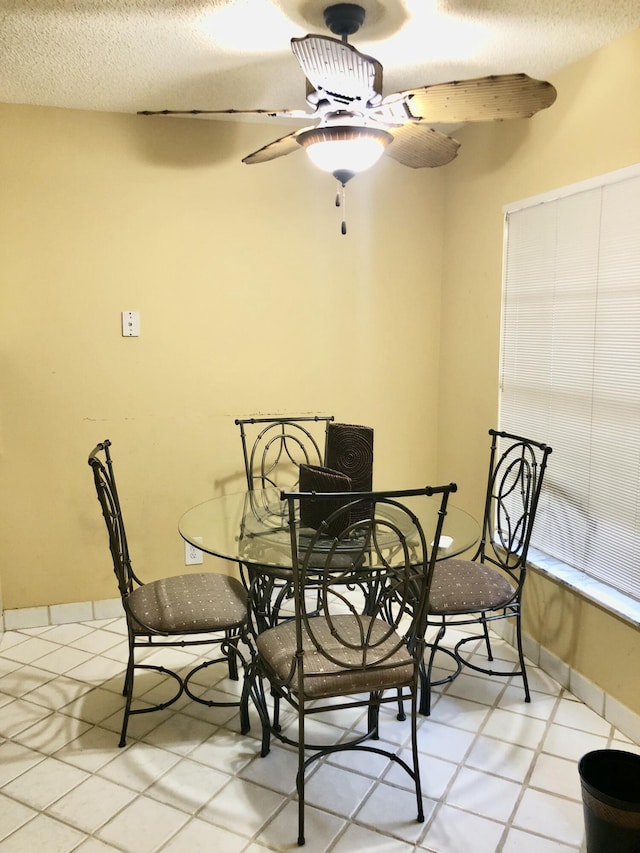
[429,559,516,616]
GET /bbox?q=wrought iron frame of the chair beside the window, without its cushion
[420,429,552,715]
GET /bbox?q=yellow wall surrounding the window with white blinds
[438,31,640,713]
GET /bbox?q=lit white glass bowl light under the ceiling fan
[297,125,393,184]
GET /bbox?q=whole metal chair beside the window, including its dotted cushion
[420,429,551,715]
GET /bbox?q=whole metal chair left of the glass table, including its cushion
[88,439,249,746]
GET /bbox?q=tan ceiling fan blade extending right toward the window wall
[390,74,556,124]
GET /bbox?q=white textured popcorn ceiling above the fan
[0,0,640,113]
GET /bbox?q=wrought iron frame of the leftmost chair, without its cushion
[88,439,251,747]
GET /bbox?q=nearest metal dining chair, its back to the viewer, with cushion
[246,484,456,845]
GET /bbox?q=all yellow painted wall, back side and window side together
[0,26,640,713]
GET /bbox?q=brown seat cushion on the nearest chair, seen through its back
[256,615,414,699]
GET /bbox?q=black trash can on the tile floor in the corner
[578,749,640,853]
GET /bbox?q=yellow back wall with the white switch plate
[0,105,444,609]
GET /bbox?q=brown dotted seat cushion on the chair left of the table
[127,572,247,634]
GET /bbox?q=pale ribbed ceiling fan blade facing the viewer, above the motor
[291,35,382,106]
